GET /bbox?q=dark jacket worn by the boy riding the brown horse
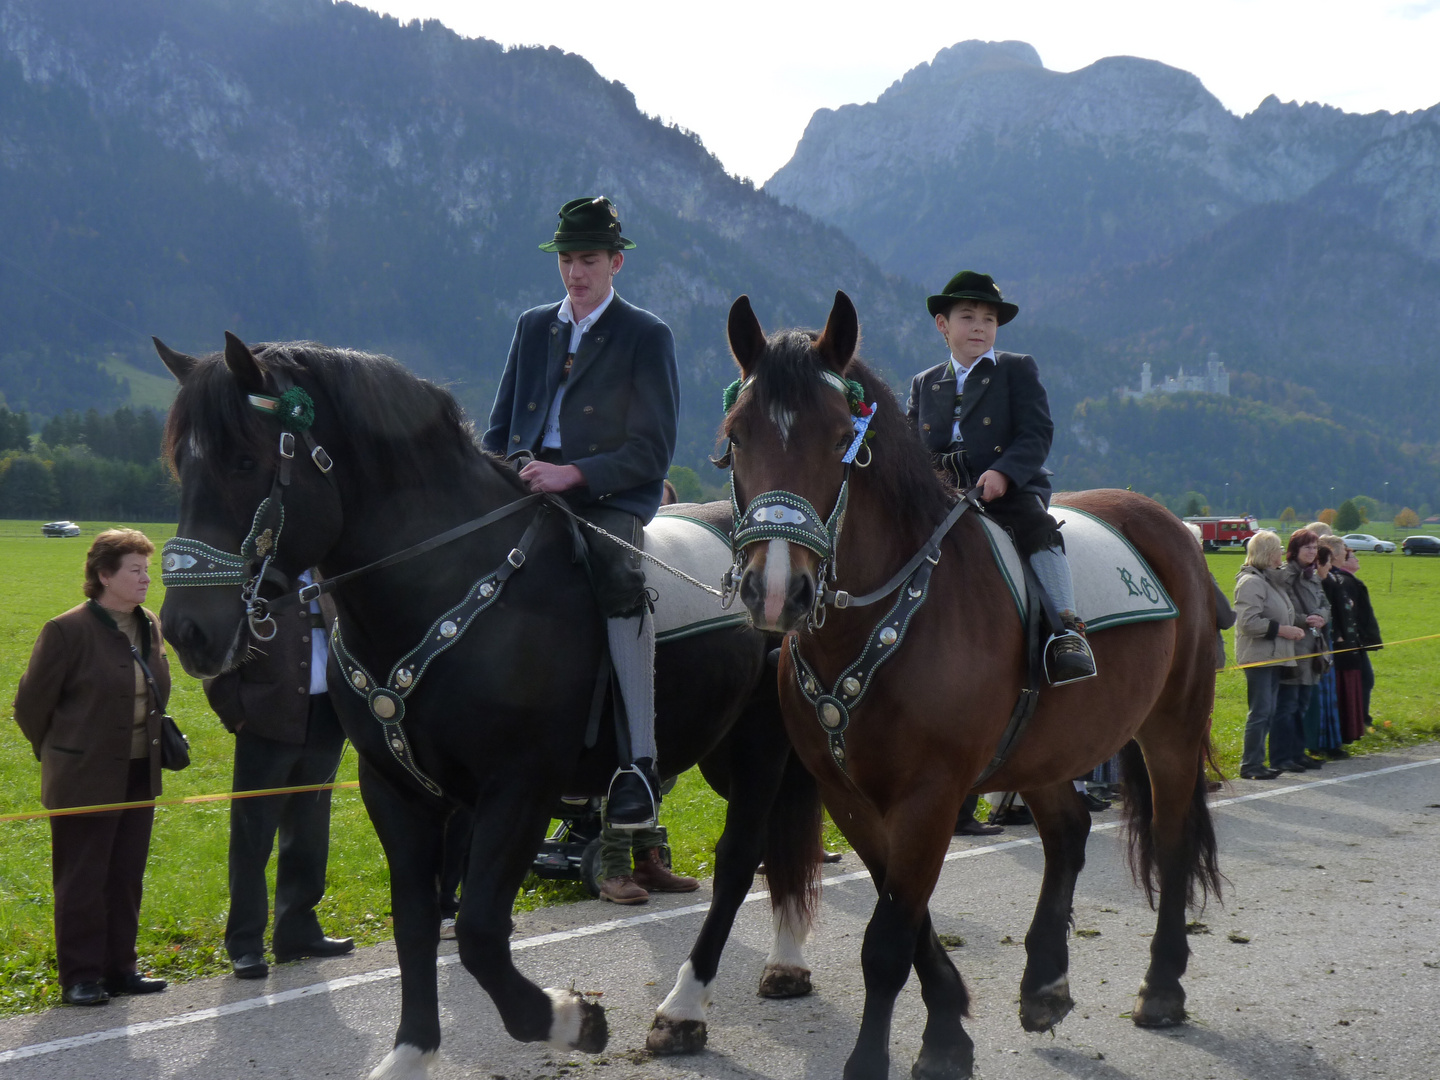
[906,351,1056,504]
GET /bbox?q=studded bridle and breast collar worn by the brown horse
[717,370,978,772]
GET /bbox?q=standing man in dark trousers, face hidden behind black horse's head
[204,570,354,979]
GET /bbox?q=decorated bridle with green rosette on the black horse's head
[160,370,334,641]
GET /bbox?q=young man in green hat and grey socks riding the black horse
[481,196,680,829]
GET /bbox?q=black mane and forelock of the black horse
[164,341,520,488]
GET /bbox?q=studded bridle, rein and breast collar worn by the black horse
[160,370,564,796]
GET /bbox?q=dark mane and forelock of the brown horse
[724,330,955,544]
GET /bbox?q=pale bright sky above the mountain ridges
[354,0,1440,183]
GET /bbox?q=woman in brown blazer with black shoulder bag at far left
[14,528,170,1005]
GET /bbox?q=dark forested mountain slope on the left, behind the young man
[0,0,922,464]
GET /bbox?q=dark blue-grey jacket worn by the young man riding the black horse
[481,294,680,521]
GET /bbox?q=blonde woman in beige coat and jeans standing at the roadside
[1236,528,1305,780]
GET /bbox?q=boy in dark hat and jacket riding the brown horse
[906,271,1094,685]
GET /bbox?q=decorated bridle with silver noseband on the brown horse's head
[721,370,876,626]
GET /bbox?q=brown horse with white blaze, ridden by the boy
[723,292,1220,1080]
